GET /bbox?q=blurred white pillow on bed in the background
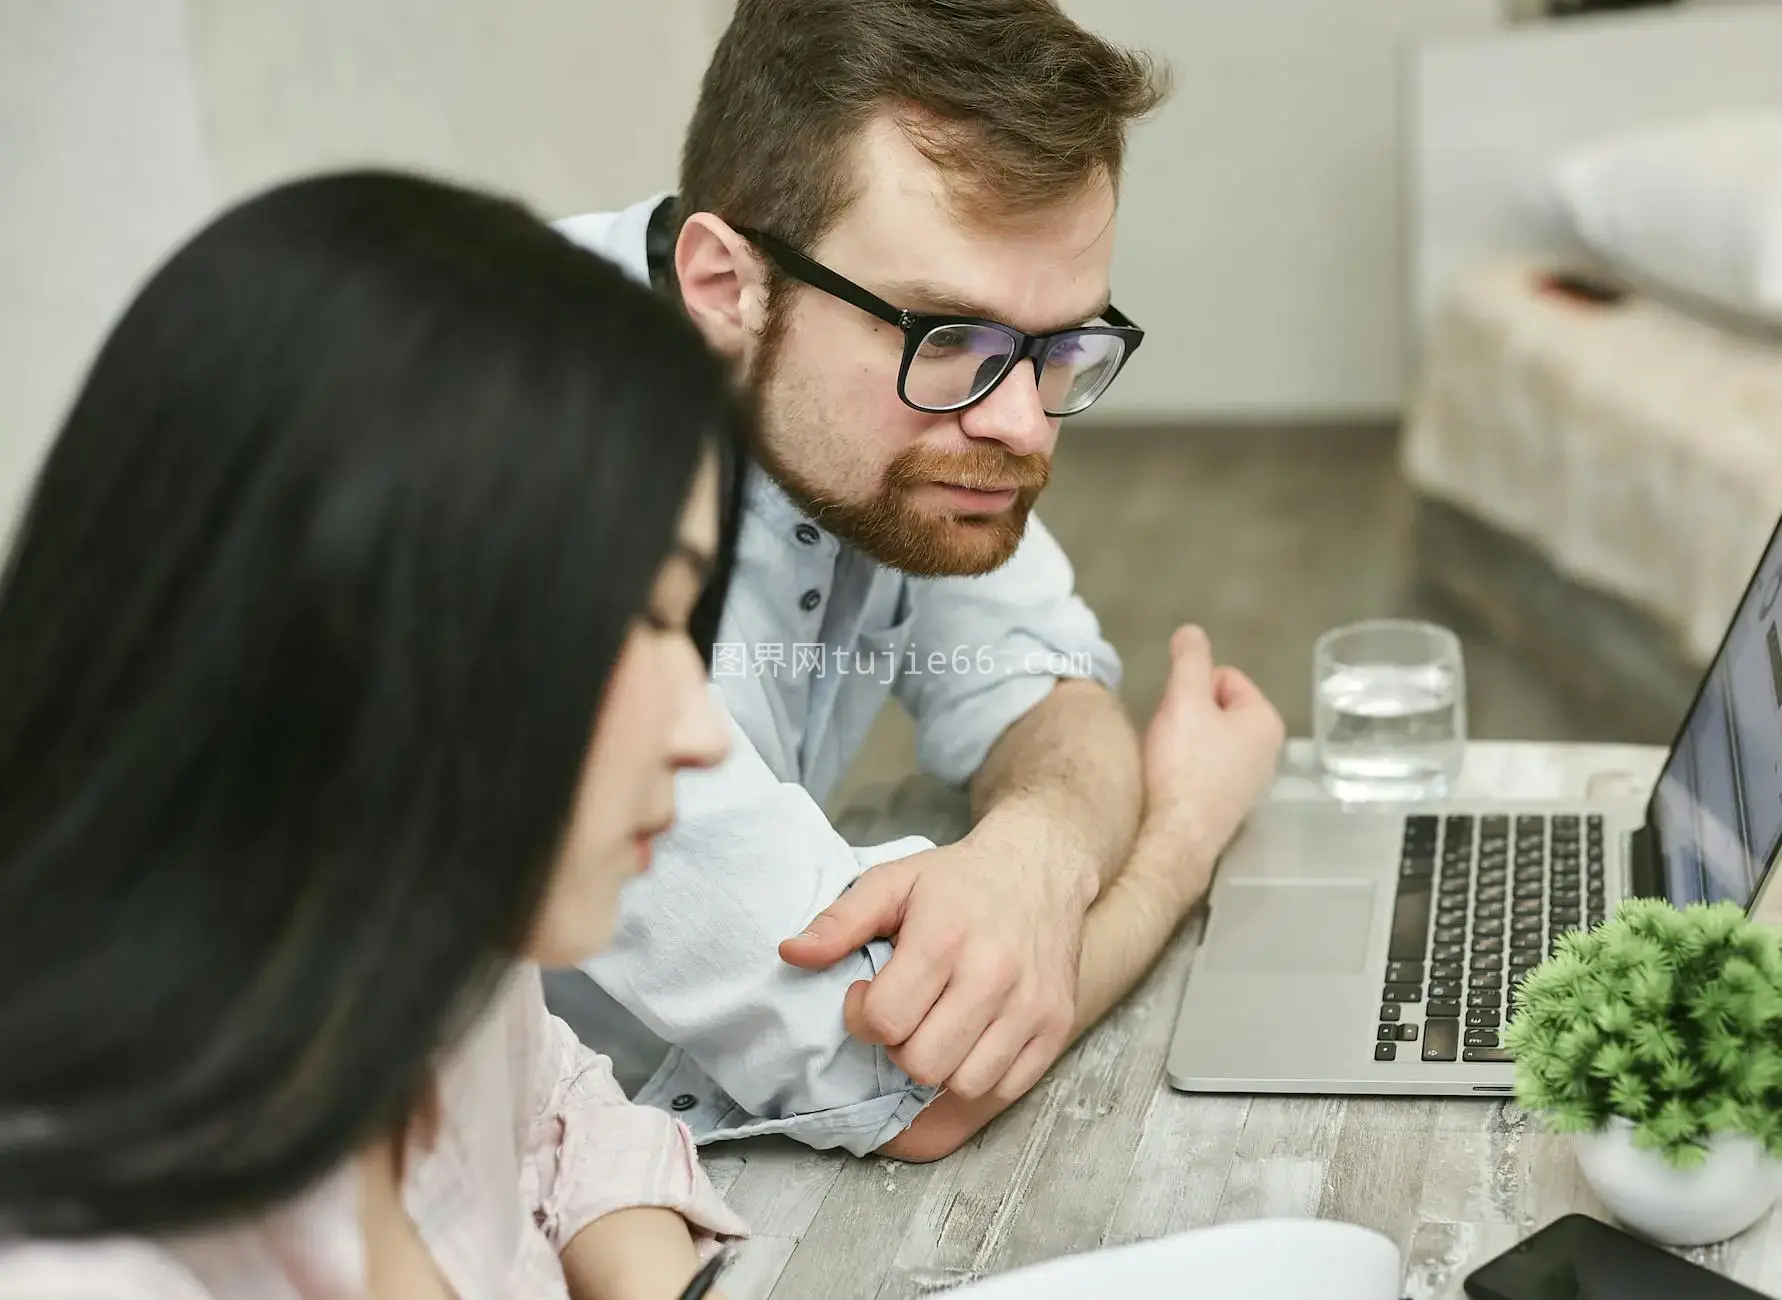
[1552,109,1782,326]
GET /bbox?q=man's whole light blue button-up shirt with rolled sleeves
[547,199,1119,1156]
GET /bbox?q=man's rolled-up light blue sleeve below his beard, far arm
[895,516,1121,785]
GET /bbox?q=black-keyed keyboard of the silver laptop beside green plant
[1374,814,1606,1063]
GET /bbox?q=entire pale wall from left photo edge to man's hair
[0,0,727,548]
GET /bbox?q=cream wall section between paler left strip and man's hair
[187,0,716,215]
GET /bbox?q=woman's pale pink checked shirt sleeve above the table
[526,968,748,1254]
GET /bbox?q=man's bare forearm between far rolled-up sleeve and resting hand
[971,680,1142,898]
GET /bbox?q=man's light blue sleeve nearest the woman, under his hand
[583,686,936,1156]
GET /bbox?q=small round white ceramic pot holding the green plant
[1574,1118,1782,1247]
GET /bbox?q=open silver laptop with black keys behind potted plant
[1165,516,1782,1095]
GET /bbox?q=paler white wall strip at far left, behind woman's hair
[0,0,212,548]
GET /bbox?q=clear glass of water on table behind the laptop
[1312,618,1467,801]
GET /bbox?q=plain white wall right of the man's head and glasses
[1066,0,1502,418]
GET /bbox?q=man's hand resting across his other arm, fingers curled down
[781,826,1083,1102]
